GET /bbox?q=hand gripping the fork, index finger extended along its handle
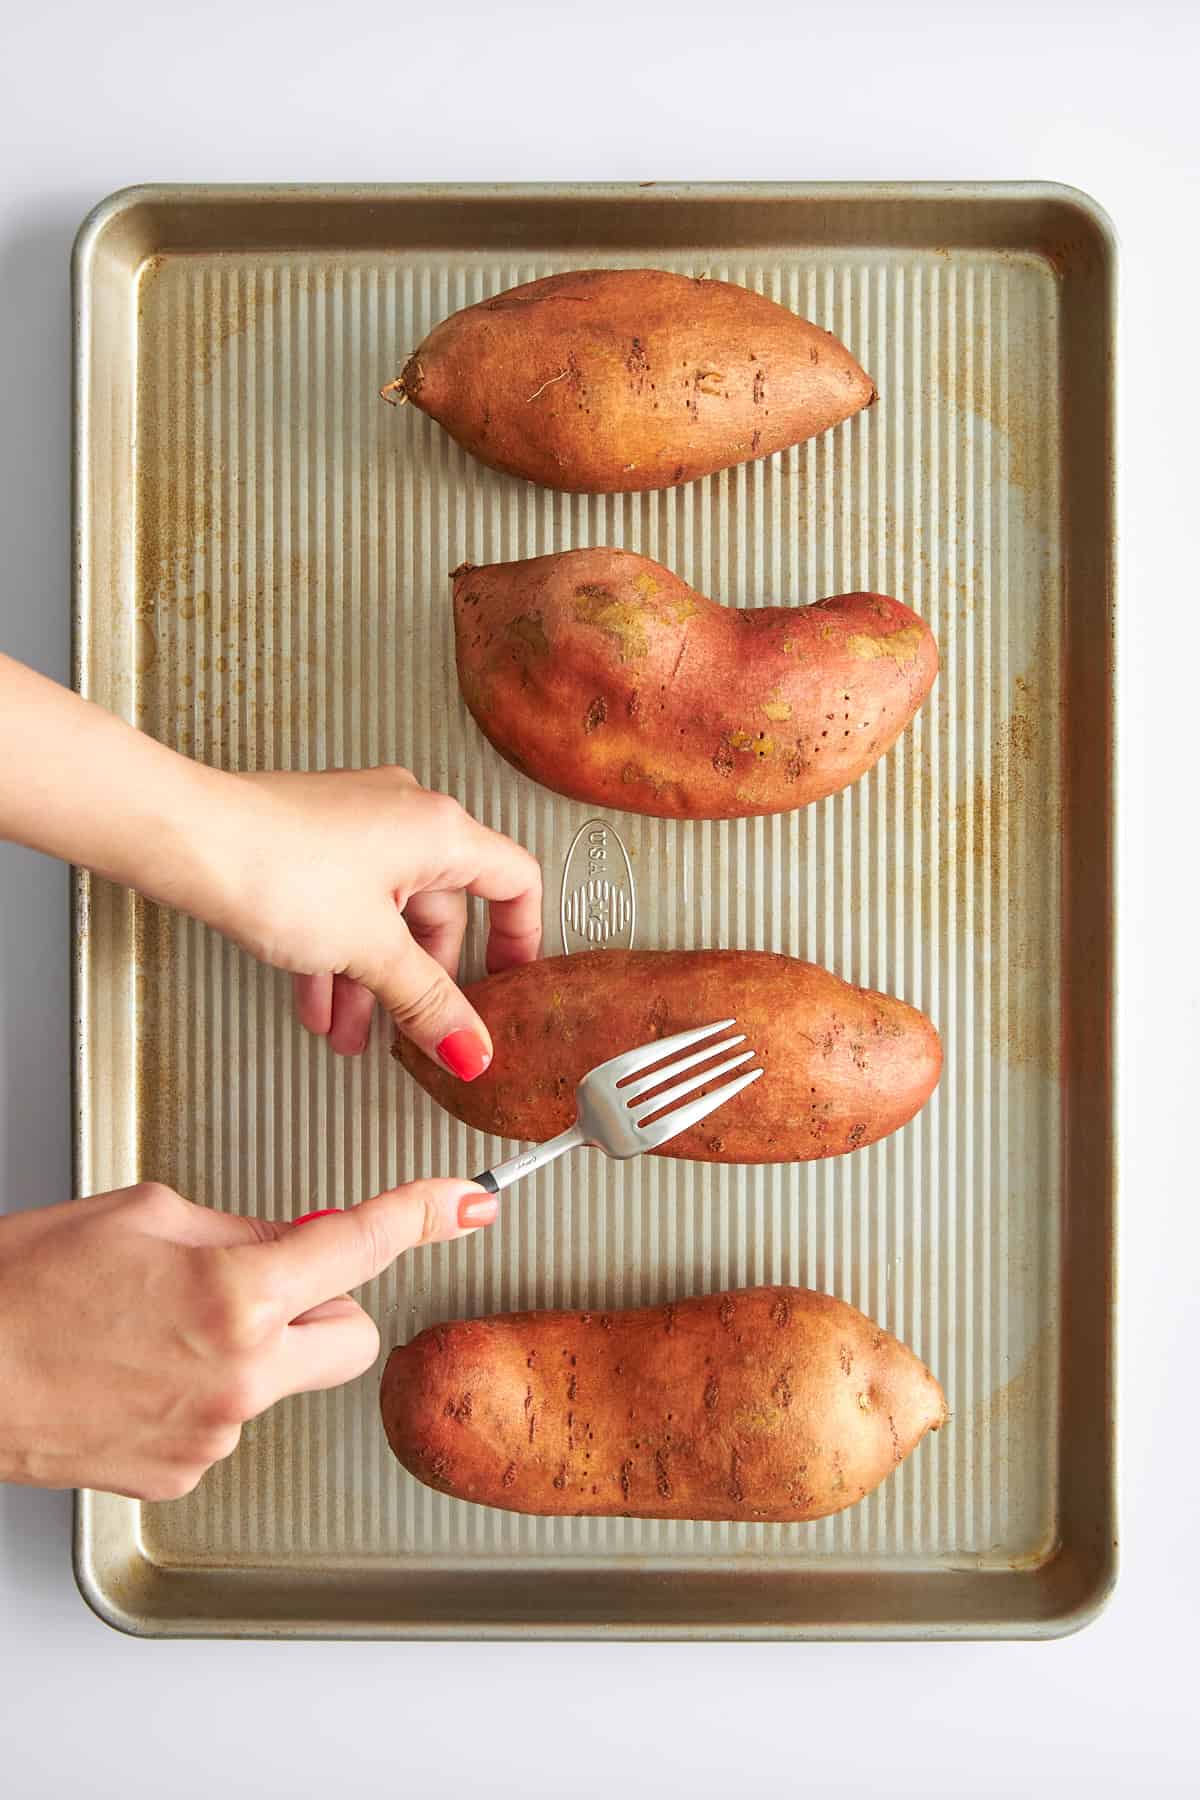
[0,1181,497,1499]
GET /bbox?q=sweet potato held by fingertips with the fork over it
[394,950,941,1163]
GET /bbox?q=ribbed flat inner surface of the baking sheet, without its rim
[122,247,1061,1571]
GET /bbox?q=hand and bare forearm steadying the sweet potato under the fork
[0,655,542,1080]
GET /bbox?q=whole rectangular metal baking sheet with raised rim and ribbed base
[67,184,1115,1638]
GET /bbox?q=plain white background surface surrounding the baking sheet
[0,0,1200,1800]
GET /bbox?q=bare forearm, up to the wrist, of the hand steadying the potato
[0,655,254,922]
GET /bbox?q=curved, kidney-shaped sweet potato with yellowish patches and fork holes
[453,549,937,819]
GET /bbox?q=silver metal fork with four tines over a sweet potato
[475,1019,763,1193]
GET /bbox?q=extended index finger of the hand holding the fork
[262,1181,497,1319]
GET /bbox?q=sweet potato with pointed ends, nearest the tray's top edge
[383,268,874,493]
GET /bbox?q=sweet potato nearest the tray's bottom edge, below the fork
[380,1287,946,1525]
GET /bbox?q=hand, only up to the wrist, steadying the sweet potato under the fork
[224,769,542,1080]
